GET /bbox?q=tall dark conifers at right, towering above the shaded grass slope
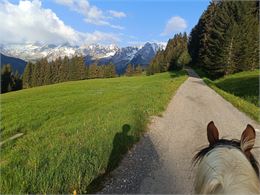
[188,1,259,78]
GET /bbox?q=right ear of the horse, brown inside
[240,124,256,156]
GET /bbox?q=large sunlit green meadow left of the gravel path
[0,71,187,193]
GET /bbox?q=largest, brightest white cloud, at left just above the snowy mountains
[0,0,120,44]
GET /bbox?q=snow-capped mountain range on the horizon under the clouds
[0,42,166,74]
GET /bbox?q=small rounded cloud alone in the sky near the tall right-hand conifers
[161,16,187,36]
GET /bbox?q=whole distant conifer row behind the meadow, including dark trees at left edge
[1,56,143,93]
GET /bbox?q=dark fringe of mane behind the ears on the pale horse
[193,139,259,177]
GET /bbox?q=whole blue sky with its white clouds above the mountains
[0,0,209,46]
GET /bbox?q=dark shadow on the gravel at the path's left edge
[98,134,160,194]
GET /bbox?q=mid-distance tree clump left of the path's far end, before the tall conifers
[147,33,190,75]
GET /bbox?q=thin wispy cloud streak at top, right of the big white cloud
[55,0,126,30]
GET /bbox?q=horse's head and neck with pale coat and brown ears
[193,121,260,194]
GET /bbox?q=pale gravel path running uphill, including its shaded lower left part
[99,69,260,194]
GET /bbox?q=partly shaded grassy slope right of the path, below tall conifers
[195,69,260,122]
